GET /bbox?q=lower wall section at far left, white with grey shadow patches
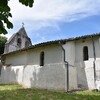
[0,66,24,84]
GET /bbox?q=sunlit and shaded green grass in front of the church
[0,85,100,100]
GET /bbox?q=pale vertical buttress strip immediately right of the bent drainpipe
[63,41,77,90]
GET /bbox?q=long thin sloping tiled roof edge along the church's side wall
[3,33,100,55]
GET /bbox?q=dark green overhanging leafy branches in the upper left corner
[0,0,34,34]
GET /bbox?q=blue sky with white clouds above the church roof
[3,0,100,44]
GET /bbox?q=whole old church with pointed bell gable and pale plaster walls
[0,27,100,92]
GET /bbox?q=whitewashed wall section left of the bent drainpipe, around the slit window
[1,45,70,91]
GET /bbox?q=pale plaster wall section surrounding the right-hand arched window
[75,38,100,89]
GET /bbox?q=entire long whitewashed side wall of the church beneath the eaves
[2,38,100,90]
